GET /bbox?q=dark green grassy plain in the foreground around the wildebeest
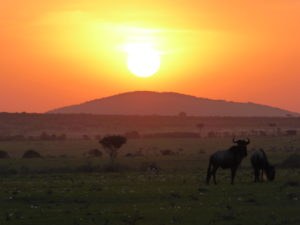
[0,137,300,225]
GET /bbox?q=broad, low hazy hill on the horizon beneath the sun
[48,91,299,117]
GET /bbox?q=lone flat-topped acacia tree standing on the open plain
[99,135,127,164]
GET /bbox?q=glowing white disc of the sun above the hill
[125,43,160,77]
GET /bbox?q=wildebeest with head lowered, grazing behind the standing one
[251,149,275,182]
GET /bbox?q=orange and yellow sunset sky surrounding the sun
[0,0,300,112]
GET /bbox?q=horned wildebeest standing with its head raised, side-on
[206,138,250,184]
